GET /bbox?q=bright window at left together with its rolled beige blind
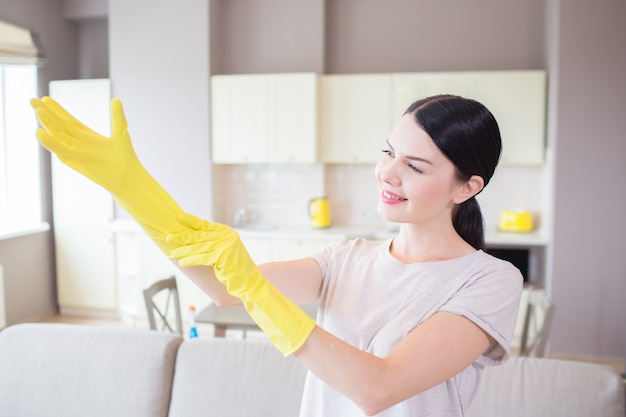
[0,20,44,237]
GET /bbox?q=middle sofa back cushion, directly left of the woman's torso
[170,338,306,417]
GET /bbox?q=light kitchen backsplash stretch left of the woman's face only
[213,164,385,227]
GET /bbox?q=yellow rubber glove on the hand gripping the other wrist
[167,213,315,356]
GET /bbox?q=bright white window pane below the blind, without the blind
[0,64,41,234]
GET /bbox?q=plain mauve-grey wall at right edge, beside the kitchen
[552,0,626,356]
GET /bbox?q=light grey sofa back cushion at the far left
[0,324,182,417]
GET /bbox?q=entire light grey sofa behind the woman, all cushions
[0,324,624,417]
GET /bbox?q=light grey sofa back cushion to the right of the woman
[466,357,624,417]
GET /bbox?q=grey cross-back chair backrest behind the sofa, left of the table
[143,276,183,336]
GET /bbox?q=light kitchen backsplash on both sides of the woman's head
[213,155,551,234]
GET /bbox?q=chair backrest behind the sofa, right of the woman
[519,288,555,357]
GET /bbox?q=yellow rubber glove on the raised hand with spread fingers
[31,97,184,255]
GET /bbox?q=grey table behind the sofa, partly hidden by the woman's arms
[196,302,319,337]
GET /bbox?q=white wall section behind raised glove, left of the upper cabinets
[109,0,212,217]
